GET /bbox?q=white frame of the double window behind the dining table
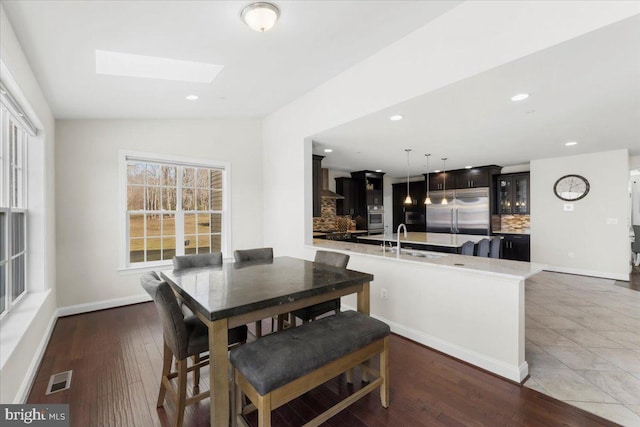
[118,150,233,272]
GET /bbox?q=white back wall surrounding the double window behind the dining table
[56,120,263,307]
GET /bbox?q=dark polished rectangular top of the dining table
[162,257,373,321]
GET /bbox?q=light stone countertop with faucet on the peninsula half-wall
[313,239,546,280]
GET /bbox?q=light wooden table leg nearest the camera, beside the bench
[207,319,229,427]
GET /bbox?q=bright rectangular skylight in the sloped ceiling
[96,50,224,83]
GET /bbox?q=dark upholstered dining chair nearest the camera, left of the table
[140,272,247,427]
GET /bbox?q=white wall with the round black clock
[531,150,630,280]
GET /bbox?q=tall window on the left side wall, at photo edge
[0,104,29,316]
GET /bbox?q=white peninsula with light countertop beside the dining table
[307,239,545,382]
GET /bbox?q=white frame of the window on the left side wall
[0,102,30,319]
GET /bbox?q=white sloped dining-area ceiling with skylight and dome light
[2,0,460,119]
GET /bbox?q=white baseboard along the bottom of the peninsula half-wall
[342,304,529,383]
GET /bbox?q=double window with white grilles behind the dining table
[124,155,228,267]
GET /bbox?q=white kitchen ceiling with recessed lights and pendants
[313,15,640,177]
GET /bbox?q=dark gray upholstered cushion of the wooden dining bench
[230,311,390,396]
